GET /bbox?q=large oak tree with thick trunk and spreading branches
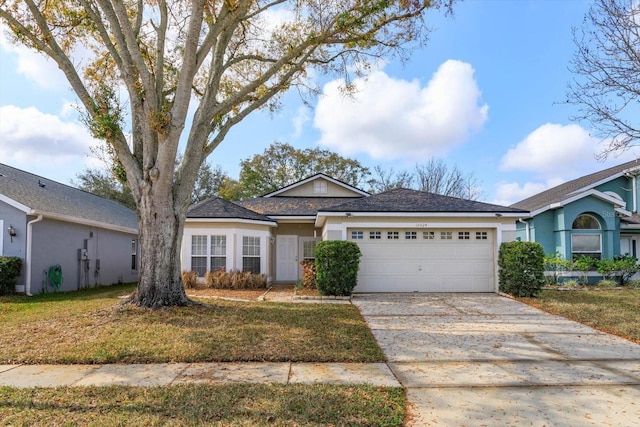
[0,0,453,309]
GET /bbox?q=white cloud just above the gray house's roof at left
[0,105,97,183]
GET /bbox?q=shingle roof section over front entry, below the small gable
[237,196,362,216]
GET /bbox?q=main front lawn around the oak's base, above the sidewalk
[0,285,384,364]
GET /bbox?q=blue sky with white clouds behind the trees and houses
[0,0,635,204]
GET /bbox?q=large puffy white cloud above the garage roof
[314,60,489,160]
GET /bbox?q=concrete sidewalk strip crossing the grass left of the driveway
[0,362,400,387]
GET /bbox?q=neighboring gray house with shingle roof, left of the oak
[0,163,139,295]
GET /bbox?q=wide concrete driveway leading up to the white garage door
[352,294,640,426]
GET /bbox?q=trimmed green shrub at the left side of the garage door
[315,240,362,296]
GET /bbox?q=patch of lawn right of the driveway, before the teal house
[520,289,640,343]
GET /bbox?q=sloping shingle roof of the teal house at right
[511,159,640,211]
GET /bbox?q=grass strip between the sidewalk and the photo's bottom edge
[0,384,404,426]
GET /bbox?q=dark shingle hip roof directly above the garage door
[322,188,528,213]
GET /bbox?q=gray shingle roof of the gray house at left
[0,163,138,230]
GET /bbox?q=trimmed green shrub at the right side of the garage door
[498,242,544,297]
